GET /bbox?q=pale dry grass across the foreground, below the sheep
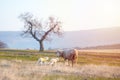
[0,60,120,80]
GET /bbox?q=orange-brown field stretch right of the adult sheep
[78,50,120,66]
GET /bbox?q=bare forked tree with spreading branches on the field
[20,13,62,51]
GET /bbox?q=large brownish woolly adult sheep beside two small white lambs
[56,49,78,67]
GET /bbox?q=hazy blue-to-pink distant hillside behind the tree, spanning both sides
[0,27,120,49]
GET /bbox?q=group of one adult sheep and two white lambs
[37,49,78,67]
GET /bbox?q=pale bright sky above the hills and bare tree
[0,0,120,31]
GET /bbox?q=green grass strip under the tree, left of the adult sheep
[0,50,55,61]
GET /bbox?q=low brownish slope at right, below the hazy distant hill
[82,44,120,49]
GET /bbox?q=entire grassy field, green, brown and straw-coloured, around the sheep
[0,49,120,80]
